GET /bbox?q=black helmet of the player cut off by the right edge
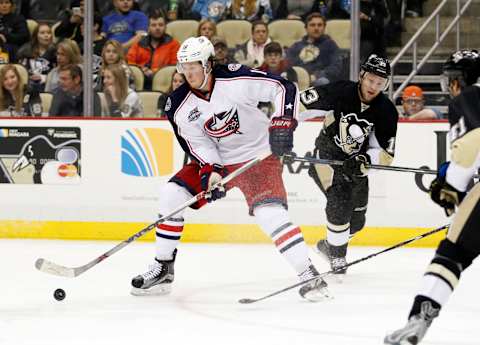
[440,49,480,92]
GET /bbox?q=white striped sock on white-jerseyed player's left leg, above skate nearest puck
[155,182,192,260]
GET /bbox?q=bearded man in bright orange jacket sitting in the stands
[127,11,180,90]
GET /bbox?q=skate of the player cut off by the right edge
[384,301,439,345]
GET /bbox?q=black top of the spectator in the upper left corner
[0,13,30,61]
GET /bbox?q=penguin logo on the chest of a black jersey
[335,113,373,155]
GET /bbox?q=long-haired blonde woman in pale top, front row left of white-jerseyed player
[103,64,143,117]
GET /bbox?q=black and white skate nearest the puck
[130,249,177,296]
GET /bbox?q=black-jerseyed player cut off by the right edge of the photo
[385,50,480,345]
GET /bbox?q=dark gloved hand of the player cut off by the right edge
[428,162,466,216]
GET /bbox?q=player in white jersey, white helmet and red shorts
[132,36,329,301]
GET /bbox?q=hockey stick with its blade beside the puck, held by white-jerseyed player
[35,152,271,278]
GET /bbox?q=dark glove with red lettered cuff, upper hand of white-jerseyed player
[269,116,298,157]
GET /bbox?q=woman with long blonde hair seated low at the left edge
[0,64,42,117]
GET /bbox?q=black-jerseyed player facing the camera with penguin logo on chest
[300,54,398,274]
